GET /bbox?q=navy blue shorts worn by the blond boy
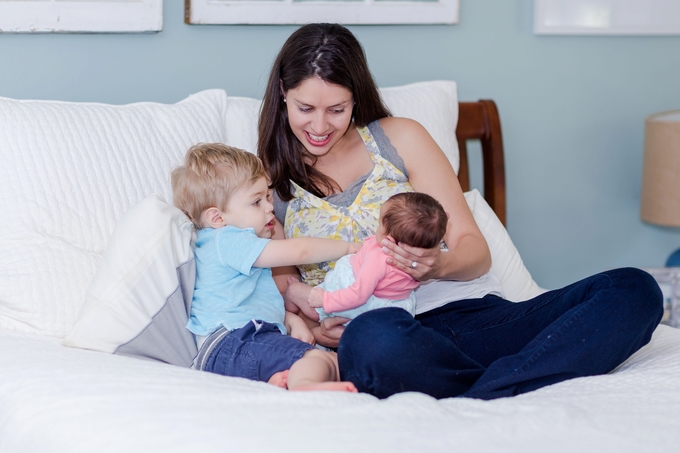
[203,320,314,382]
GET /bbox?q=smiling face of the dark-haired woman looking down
[285,77,354,161]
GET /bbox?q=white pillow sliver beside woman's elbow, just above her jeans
[465,189,545,302]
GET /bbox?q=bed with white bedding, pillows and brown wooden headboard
[0,81,680,453]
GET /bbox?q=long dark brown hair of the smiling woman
[257,24,391,201]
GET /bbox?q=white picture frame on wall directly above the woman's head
[185,0,460,25]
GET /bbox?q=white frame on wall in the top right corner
[534,0,680,35]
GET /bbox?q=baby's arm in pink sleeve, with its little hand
[309,252,388,313]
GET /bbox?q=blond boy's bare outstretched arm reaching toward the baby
[253,237,361,267]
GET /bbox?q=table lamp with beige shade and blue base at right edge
[640,110,680,266]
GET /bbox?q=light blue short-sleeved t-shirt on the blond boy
[187,226,286,336]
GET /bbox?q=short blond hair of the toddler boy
[171,143,267,229]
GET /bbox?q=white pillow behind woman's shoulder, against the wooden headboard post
[380,80,460,174]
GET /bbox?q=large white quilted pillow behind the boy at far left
[0,90,227,338]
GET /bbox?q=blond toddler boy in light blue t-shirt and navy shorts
[172,143,360,392]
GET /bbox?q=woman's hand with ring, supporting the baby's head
[381,236,441,281]
